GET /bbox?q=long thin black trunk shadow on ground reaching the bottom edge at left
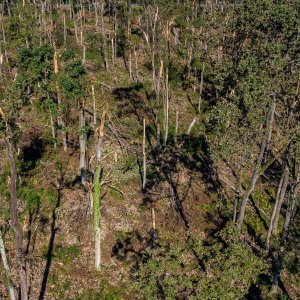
[39,175,63,300]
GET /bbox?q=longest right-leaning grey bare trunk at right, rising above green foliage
[237,96,276,229]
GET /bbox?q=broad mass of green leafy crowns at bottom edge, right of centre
[134,226,267,299]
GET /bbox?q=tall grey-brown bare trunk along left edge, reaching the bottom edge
[6,122,28,300]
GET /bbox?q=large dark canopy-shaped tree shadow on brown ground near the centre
[142,135,221,229]
